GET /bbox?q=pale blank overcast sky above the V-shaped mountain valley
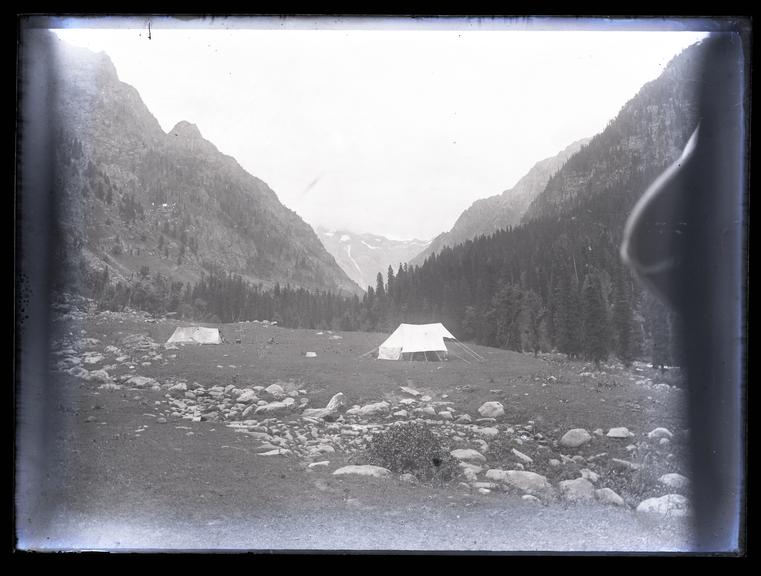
[56,20,705,240]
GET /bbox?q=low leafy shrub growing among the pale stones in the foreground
[367,422,459,483]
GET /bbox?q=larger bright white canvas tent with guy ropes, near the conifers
[368,323,483,360]
